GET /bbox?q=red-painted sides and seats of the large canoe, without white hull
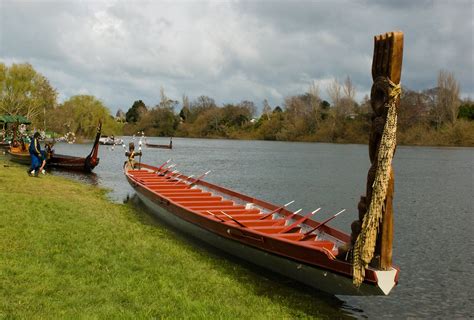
[125,164,398,294]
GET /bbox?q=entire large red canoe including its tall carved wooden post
[124,31,404,295]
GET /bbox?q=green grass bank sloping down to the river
[0,159,345,319]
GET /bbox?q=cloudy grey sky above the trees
[0,0,474,112]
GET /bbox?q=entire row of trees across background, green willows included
[0,62,474,146]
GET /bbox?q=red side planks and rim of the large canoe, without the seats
[124,164,390,292]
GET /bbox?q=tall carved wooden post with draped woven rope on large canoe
[351,32,403,285]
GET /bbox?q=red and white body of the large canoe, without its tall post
[125,164,398,295]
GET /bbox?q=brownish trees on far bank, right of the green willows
[123,70,474,146]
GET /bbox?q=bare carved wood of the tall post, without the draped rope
[351,32,403,278]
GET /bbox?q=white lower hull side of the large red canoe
[132,185,397,295]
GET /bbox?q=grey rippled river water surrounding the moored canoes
[29,138,474,319]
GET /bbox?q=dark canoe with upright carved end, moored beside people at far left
[8,123,102,172]
